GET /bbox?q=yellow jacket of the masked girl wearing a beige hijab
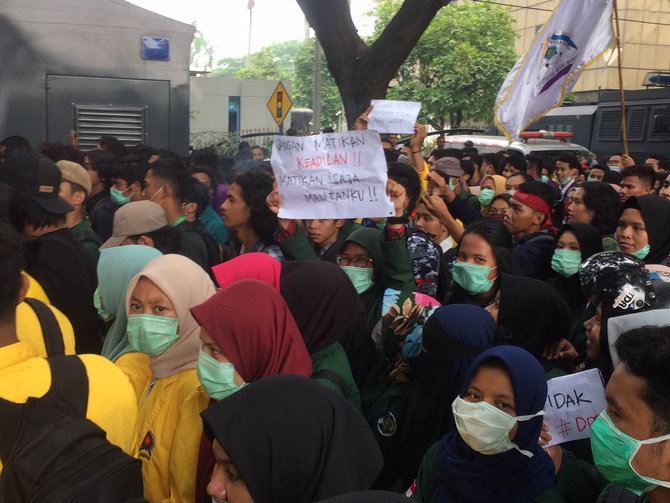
[131,369,209,503]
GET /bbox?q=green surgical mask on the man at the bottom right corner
[591,411,670,495]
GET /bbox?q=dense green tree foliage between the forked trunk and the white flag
[373,0,516,129]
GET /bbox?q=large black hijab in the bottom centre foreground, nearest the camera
[201,374,383,503]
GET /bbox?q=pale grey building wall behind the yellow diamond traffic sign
[190,77,291,134]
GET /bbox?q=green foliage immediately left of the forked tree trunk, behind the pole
[292,38,342,130]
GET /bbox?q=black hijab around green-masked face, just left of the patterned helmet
[551,224,603,315]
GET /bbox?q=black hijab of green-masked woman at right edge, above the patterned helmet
[621,194,670,265]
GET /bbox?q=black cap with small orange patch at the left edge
[0,152,74,215]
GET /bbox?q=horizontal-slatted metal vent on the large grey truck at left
[74,105,146,150]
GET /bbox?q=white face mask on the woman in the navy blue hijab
[451,396,544,458]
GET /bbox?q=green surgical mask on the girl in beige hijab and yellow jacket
[126,314,179,356]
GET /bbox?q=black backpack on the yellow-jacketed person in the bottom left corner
[0,356,144,503]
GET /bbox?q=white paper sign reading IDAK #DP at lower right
[544,369,607,446]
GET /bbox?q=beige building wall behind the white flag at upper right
[505,0,670,92]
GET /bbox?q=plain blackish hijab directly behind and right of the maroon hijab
[279,260,363,355]
